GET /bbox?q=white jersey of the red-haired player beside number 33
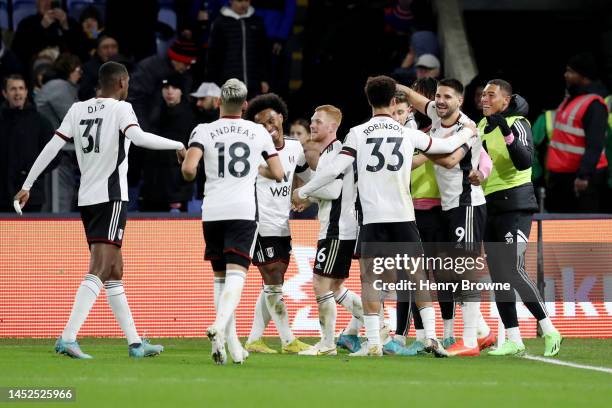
[317,140,357,240]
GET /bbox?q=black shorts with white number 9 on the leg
[442,204,487,252]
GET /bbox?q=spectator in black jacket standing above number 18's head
[208,0,270,98]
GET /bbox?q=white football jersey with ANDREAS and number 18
[189,116,278,221]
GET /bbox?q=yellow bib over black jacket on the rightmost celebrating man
[478,116,531,196]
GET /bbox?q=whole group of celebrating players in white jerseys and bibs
[15,63,562,364]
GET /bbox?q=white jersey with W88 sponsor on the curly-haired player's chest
[257,137,308,237]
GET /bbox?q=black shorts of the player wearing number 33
[356,221,423,258]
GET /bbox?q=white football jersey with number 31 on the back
[56,98,138,206]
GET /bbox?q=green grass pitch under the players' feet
[0,338,612,408]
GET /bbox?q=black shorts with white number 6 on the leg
[312,239,356,279]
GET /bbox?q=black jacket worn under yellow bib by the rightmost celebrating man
[483,95,538,215]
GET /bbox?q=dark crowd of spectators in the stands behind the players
[0,0,612,212]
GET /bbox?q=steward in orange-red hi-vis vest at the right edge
[546,53,608,213]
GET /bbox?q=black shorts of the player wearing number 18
[202,220,257,271]
